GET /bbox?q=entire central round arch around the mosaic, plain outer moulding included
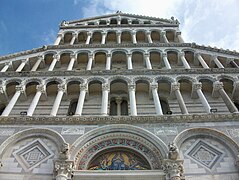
[70,125,167,170]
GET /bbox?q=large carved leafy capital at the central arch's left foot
[54,160,74,180]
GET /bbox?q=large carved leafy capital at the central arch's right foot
[162,159,184,180]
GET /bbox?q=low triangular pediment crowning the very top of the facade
[61,12,179,27]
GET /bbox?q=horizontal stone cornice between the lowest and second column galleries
[0,68,239,78]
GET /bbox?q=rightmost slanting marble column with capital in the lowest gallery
[213,81,238,113]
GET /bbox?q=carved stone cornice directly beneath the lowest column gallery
[0,114,239,125]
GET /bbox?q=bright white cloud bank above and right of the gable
[74,0,239,51]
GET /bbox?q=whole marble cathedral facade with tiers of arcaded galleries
[0,12,239,180]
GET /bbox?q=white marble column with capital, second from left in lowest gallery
[27,85,46,116]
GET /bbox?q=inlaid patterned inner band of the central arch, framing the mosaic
[75,133,162,170]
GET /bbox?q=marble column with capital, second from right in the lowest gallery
[192,83,211,113]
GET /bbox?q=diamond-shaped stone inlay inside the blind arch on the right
[185,140,224,169]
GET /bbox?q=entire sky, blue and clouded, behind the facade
[0,0,239,55]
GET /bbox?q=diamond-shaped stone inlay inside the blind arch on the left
[13,139,54,172]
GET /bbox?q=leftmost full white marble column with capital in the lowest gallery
[2,85,25,116]
